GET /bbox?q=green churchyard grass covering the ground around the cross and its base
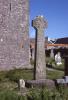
[0,69,68,100]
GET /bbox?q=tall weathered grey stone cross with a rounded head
[32,16,47,80]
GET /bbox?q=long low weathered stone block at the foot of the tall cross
[25,79,55,88]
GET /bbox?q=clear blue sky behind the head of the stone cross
[29,0,68,38]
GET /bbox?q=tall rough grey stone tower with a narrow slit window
[0,0,29,70]
